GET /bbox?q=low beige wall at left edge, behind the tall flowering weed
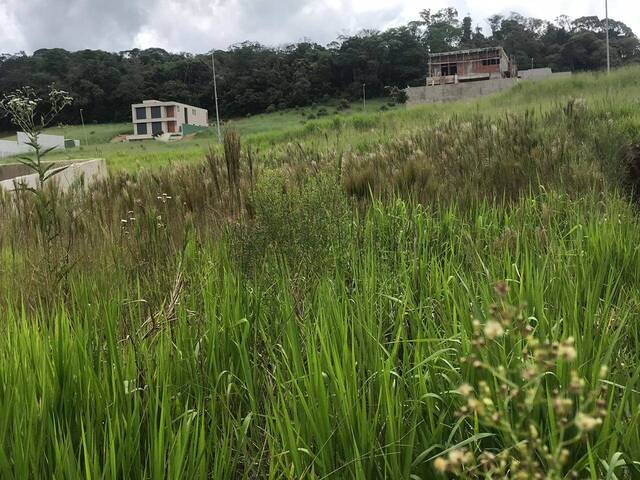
[0,158,107,191]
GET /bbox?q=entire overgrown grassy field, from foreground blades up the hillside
[0,68,640,480]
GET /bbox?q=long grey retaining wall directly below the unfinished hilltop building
[406,78,517,106]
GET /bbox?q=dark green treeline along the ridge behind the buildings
[0,8,640,129]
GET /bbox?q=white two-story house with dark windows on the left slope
[128,100,209,140]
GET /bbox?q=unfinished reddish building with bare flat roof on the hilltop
[427,47,518,86]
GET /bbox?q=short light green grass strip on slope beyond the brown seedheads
[5,67,640,171]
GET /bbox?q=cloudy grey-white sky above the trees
[0,0,640,53]
